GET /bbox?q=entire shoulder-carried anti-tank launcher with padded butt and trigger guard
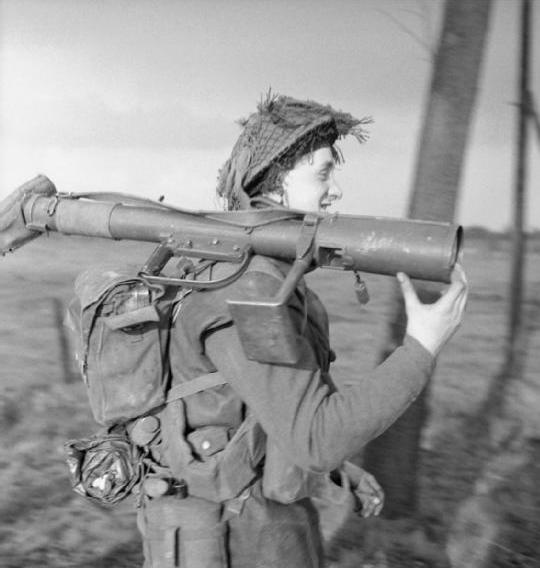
[0,176,462,361]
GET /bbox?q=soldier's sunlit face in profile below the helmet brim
[283,146,342,212]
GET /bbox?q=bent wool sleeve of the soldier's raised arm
[205,326,434,472]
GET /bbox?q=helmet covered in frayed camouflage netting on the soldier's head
[217,93,371,209]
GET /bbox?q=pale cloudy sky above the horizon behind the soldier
[0,0,540,230]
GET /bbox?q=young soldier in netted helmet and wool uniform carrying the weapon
[139,96,467,568]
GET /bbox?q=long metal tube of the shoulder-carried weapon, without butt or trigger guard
[24,196,462,282]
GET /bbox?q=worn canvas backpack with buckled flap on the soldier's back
[66,268,184,427]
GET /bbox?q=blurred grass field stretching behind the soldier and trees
[0,235,540,568]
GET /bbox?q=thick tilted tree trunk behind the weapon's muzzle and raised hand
[364,0,490,518]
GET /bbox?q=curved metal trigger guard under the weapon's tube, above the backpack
[138,241,252,290]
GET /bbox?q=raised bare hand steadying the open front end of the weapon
[397,264,468,356]
